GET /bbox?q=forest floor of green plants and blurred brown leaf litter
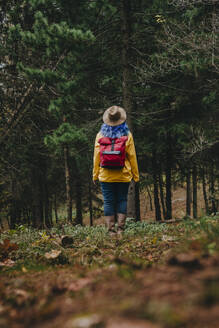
[0,216,219,328]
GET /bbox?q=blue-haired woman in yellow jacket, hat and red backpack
[93,106,139,234]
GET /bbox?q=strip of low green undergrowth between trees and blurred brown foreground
[0,216,219,271]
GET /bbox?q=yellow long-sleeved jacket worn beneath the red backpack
[93,132,139,182]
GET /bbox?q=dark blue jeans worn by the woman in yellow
[100,182,129,216]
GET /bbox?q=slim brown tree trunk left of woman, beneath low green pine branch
[64,144,72,223]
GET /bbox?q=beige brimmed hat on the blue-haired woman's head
[103,106,126,126]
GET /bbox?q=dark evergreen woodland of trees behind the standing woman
[0,0,219,228]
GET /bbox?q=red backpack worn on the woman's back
[98,136,128,169]
